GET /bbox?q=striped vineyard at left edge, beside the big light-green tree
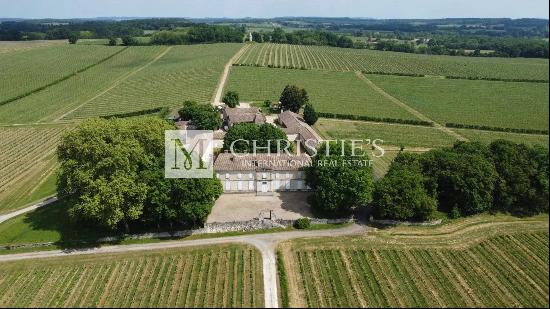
[0,125,69,214]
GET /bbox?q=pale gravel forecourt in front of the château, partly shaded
[207,192,312,223]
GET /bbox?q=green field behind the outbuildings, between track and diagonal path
[225,67,416,119]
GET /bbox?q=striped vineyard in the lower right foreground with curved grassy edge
[279,216,549,307]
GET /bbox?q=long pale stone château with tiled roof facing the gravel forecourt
[214,153,311,195]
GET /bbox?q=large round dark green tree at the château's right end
[306,143,374,217]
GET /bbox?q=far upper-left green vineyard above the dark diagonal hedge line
[0,45,122,103]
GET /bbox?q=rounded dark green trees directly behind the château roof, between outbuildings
[223,123,292,153]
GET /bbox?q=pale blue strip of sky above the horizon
[0,0,548,19]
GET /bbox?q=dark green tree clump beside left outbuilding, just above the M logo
[178,101,222,131]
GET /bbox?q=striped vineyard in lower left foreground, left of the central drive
[0,245,264,308]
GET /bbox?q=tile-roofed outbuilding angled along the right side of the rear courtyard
[278,111,323,154]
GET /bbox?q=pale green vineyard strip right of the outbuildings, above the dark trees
[315,118,456,148]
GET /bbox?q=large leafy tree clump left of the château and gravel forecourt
[57,117,222,232]
